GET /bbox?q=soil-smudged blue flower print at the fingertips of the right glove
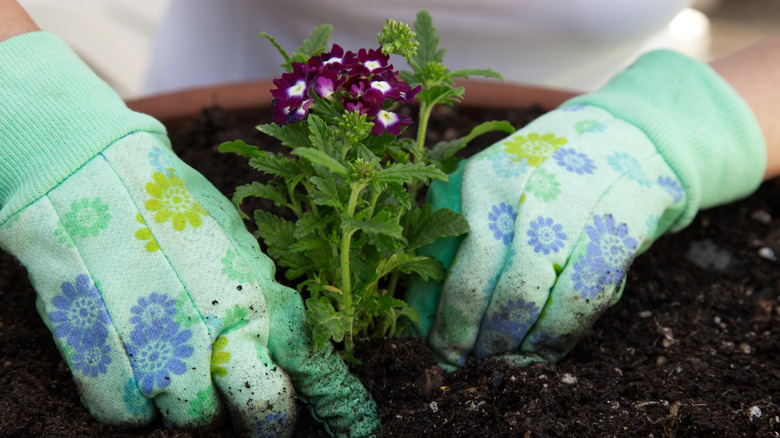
[474,298,541,357]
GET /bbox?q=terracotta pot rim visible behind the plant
[127,80,578,128]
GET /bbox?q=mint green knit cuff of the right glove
[563,50,766,231]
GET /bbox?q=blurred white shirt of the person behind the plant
[144,0,692,93]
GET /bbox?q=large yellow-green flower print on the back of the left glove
[144,172,208,231]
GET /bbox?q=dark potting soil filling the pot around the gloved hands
[0,103,780,437]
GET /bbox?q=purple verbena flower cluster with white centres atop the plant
[271,44,421,135]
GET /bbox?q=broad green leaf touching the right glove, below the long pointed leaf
[409,204,469,250]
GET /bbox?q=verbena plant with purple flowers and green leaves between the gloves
[219,11,514,358]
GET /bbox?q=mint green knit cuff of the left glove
[0,32,165,224]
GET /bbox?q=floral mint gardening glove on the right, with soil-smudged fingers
[408,51,766,369]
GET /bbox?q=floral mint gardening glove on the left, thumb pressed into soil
[0,32,378,436]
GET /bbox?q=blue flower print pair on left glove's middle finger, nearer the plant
[125,293,194,394]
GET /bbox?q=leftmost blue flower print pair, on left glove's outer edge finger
[48,274,111,377]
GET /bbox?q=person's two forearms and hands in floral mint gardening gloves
[0,0,780,435]
